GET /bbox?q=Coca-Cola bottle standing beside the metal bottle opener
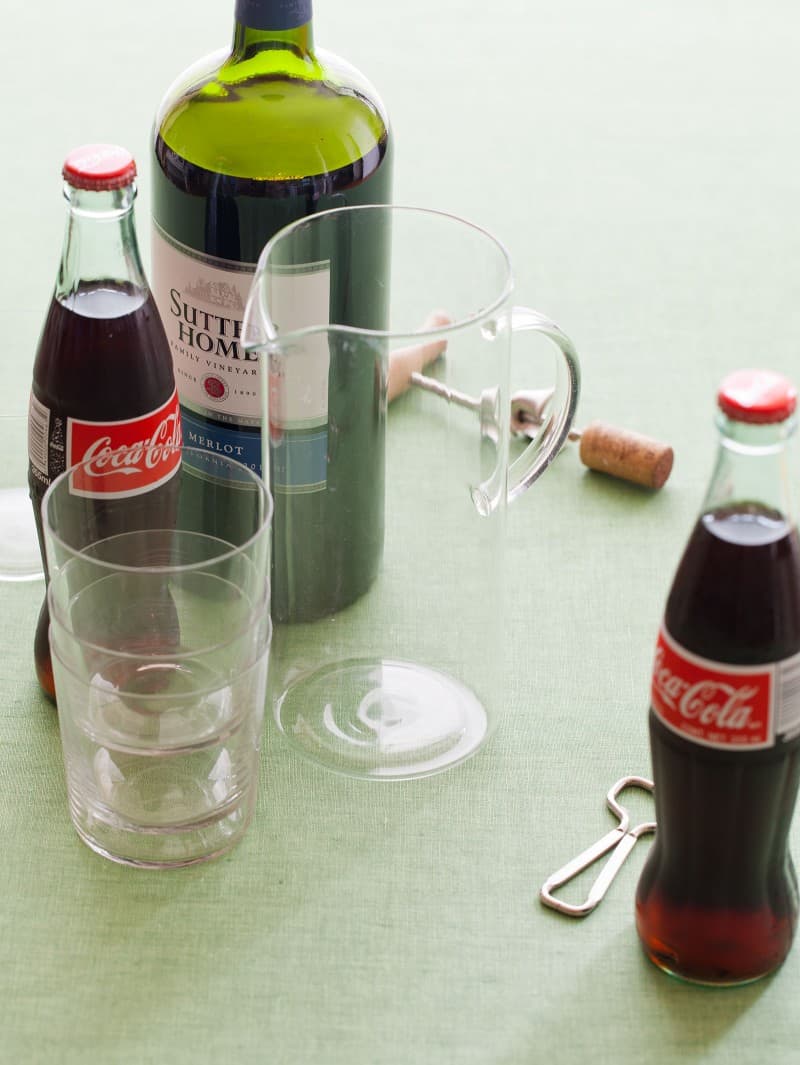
[636,371,800,984]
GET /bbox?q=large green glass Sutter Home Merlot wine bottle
[151,0,392,620]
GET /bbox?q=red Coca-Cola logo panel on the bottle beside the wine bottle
[67,390,181,498]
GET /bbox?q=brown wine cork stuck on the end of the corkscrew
[579,422,673,488]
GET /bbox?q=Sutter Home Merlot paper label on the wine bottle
[151,224,330,493]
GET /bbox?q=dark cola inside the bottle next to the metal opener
[636,506,800,984]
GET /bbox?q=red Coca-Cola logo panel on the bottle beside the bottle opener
[652,628,774,750]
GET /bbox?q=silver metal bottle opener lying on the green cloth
[539,776,655,917]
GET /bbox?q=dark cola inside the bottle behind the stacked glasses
[29,280,175,699]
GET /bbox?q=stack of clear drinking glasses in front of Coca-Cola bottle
[43,448,272,868]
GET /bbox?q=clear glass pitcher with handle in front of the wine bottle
[243,206,578,779]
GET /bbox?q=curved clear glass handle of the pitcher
[508,307,581,503]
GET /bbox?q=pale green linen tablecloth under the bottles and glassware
[0,0,800,1065]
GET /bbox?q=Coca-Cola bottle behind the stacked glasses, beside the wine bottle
[28,144,181,699]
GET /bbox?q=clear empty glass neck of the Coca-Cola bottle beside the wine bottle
[55,183,147,302]
